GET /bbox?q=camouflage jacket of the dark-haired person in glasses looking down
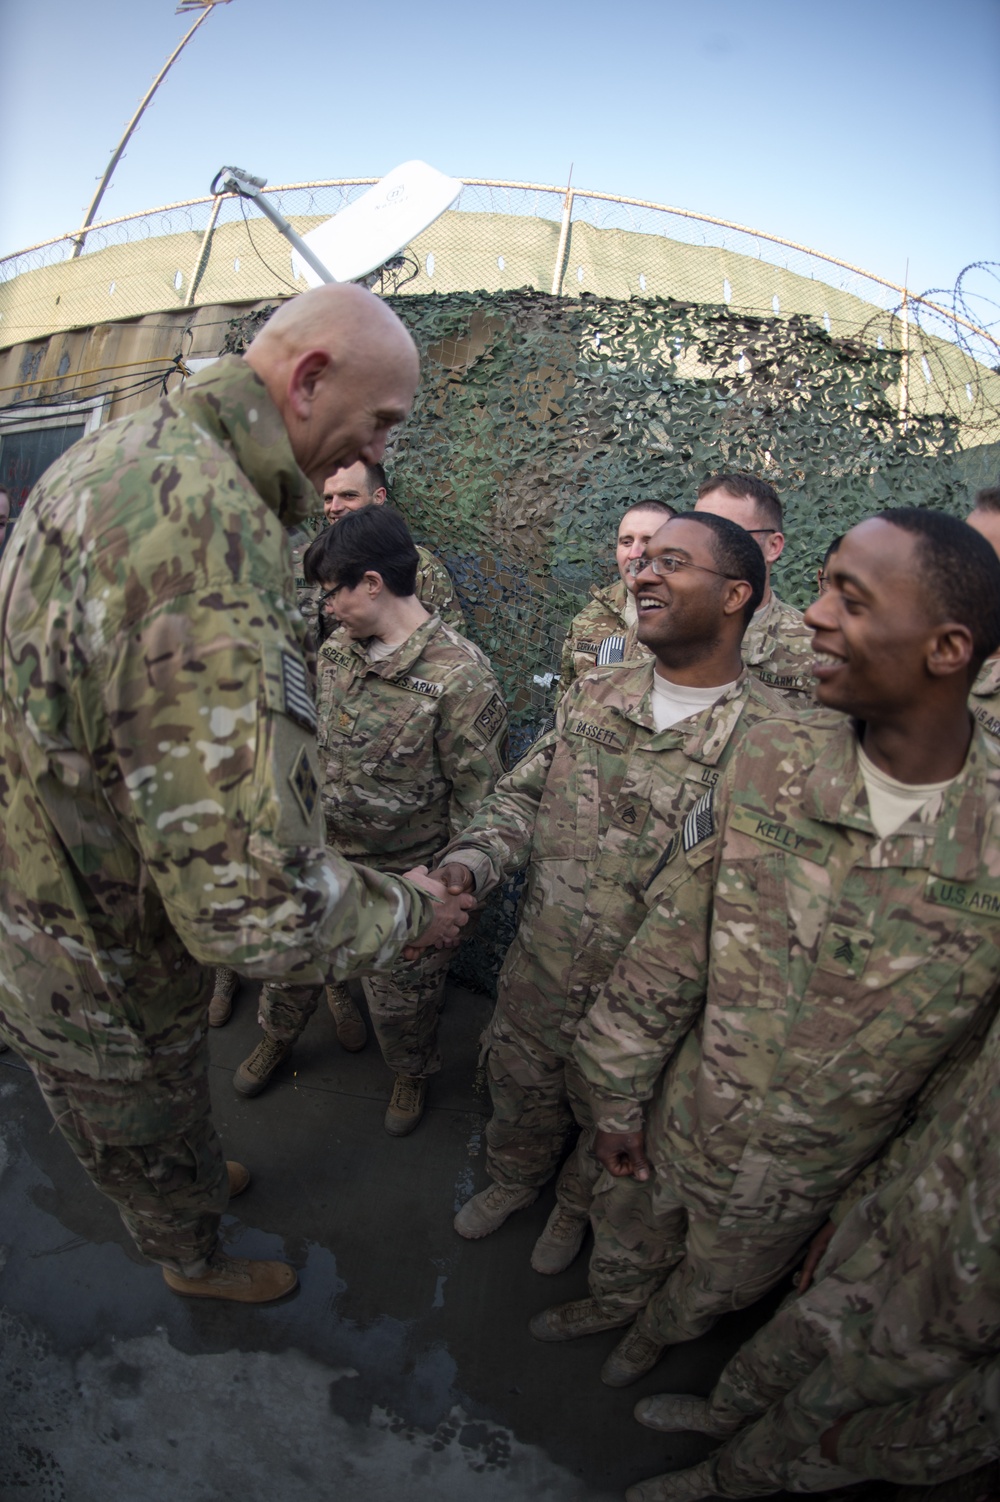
[318,616,508,871]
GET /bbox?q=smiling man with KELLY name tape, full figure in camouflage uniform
[552,509,1000,1386]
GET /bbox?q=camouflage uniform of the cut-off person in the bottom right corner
[734,1003,1000,1485]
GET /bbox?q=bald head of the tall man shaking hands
[243,282,420,490]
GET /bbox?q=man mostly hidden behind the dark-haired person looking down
[209,460,465,1027]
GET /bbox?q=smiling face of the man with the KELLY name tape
[805,517,940,721]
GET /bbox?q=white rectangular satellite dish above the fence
[291,162,462,287]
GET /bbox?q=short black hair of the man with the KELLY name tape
[878,506,1000,674]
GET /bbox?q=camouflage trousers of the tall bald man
[32,1042,230,1274]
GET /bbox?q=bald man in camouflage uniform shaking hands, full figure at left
[0,285,464,1302]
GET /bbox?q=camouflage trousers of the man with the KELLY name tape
[589,1173,826,1346]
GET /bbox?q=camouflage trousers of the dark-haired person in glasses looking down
[257,949,449,1077]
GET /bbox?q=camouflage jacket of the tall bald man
[0,356,432,1080]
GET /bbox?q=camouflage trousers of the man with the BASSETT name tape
[483,1005,593,1215]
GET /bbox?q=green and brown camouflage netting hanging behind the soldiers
[227,290,994,991]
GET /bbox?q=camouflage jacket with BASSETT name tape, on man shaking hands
[441,659,787,1050]
